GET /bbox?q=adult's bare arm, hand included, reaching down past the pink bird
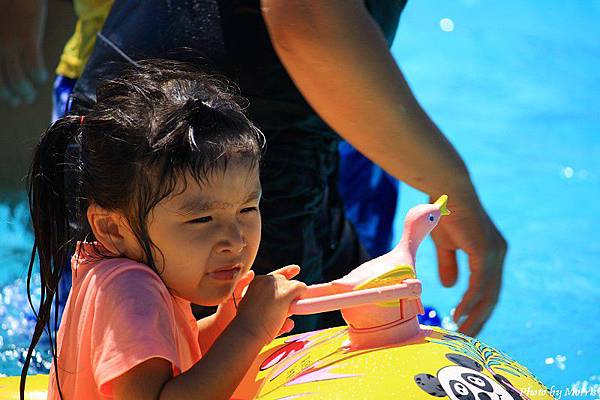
[261,0,507,335]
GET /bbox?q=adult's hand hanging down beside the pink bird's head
[431,195,507,336]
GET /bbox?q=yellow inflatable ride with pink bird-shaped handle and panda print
[0,196,552,400]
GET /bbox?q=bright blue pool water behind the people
[0,0,600,398]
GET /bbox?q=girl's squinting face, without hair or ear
[148,160,261,306]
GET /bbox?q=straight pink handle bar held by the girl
[290,279,421,315]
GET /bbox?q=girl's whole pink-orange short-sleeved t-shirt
[48,244,201,400]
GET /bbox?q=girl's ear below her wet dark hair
[87,203,133,256]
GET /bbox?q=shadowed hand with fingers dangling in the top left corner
[0,0,48,106]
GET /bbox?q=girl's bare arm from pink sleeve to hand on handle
[112,266,306,400]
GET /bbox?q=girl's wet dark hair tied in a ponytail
[21,60,264,398]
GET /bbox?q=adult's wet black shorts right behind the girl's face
[254,130,369,331]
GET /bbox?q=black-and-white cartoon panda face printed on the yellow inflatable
[414,354,522,400]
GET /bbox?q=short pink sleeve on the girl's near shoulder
[90,267,180,396]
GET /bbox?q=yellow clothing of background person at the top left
[56,0,114,79]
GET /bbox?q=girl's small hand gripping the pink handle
[236,265,306,344]
